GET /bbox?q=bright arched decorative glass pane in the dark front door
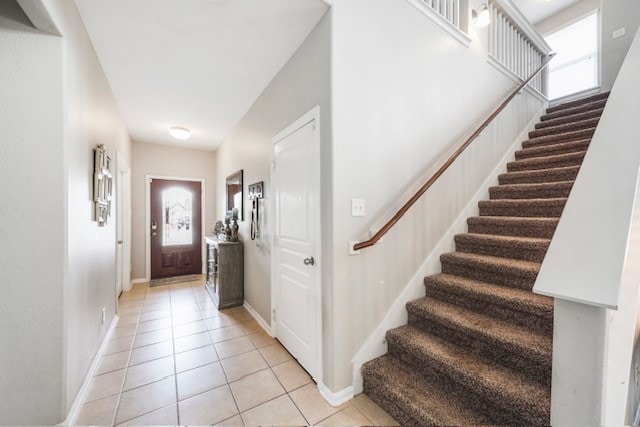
[162,187,193,246]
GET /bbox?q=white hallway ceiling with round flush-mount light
[75,0,328,150]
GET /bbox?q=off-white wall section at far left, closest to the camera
[0,1,66,425]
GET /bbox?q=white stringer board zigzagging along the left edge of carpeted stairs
[352,106,546,394]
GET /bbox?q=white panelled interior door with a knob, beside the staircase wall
[272,108,322,378]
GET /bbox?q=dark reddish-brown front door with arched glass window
[149,179,202,279]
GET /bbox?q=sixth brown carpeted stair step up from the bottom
[454,233,551,262]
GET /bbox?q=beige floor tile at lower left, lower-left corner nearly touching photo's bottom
[116,377,176,424]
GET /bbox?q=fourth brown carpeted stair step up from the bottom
[424,273,553,321]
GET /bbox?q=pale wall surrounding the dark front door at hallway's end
[131,141,216,279]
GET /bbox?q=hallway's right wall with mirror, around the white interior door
[216,13,331,323]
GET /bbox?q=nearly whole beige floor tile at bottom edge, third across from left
[178,385,238,425]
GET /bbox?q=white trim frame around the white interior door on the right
[269,105,323,384]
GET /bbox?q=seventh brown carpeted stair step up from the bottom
[467,216,559,239]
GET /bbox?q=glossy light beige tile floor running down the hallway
[76,279,397,426]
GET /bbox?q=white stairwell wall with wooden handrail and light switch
[325,0,542,392]
